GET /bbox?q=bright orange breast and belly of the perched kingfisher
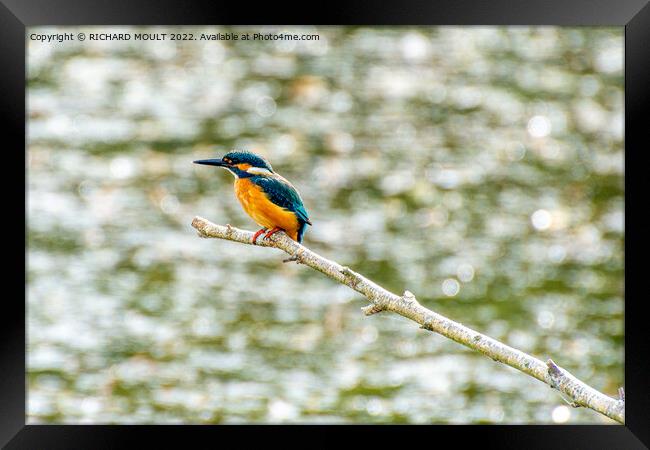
[235,178,298,240]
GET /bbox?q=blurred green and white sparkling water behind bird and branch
[27,27,624,423]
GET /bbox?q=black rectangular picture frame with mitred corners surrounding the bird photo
[0,0,650,449]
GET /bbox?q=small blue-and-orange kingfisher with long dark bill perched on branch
[193,151,312,244]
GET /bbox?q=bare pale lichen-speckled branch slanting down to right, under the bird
[192,216,625,424]
